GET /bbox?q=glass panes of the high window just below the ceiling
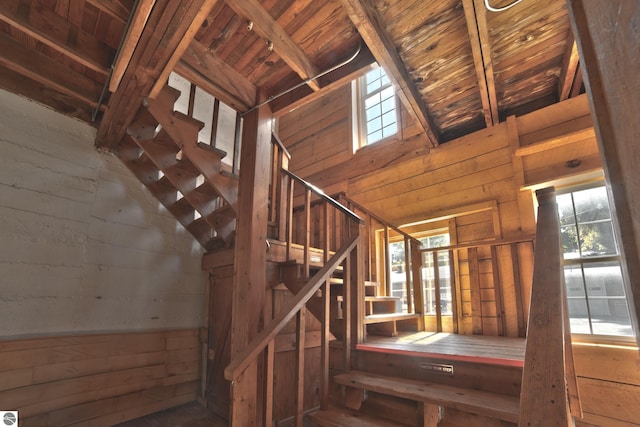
[359,67,398,145]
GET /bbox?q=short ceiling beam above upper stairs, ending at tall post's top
[175,40,257,111]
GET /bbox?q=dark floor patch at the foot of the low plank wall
[117,402,228,427]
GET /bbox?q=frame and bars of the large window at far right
[556,179,637,344]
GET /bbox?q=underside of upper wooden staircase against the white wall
[118,86,238,250]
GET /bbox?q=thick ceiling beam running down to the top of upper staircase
[96,0,212,149]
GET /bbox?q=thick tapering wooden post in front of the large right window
[518,187,581,426]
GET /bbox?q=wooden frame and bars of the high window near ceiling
[351,65,401,153]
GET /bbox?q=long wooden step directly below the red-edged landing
[333,371,520,423]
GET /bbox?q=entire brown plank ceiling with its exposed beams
[0,0,584,149]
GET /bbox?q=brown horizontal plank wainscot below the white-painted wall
[0,329,201,427]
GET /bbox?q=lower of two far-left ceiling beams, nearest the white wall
[0,33,102,107]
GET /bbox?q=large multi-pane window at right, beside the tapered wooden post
[556,186,633,336]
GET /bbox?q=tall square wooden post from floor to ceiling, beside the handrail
[231,106,272,427]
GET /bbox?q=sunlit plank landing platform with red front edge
[356,332,526,367]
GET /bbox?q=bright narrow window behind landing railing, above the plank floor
[419,233,453,315]
